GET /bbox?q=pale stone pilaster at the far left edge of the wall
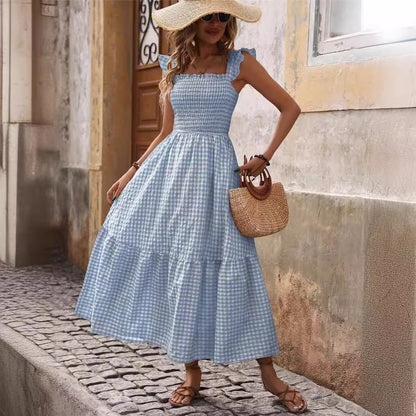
[0,1,33,265]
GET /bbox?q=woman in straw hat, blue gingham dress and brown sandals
[75,0,307,413]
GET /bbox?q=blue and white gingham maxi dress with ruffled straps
[75,48,279,364]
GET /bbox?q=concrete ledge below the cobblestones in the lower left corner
[0,324,117,416]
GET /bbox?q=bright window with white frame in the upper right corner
[314,0,416,56]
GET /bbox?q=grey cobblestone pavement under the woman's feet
[0,262,374,416]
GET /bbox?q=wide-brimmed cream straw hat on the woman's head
[152,0,261,30]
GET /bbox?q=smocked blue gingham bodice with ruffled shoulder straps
[159,48,256,134]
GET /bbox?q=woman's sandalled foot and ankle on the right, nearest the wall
[257,357,307,413]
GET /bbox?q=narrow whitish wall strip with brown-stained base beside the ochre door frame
[66,0,91,267]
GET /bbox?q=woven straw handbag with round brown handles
[228,155,289,237]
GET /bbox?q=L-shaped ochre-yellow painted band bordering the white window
[283,0,416,113]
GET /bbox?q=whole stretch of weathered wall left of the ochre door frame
[0,0,90,266]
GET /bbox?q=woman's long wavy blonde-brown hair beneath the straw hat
[159,16,238,114]
